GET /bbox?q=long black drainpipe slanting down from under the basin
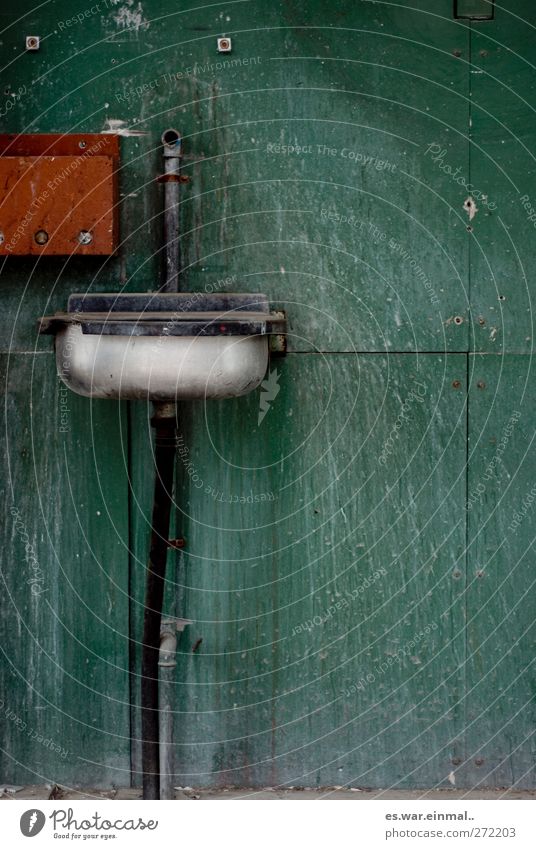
[141,403,177,799]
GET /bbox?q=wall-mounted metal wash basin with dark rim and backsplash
[39,292,284,401]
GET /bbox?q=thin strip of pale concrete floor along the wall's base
[0,784,536,802]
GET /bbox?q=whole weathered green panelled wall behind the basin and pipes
[0,0,536,788]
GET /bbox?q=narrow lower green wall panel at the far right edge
[464,354,536,787]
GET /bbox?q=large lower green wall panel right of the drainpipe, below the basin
[170,354,466,785]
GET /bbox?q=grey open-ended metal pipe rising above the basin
[161,129,182,292]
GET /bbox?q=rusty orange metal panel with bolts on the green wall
[0,134,119,256]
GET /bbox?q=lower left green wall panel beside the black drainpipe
[0,353,129,784]
